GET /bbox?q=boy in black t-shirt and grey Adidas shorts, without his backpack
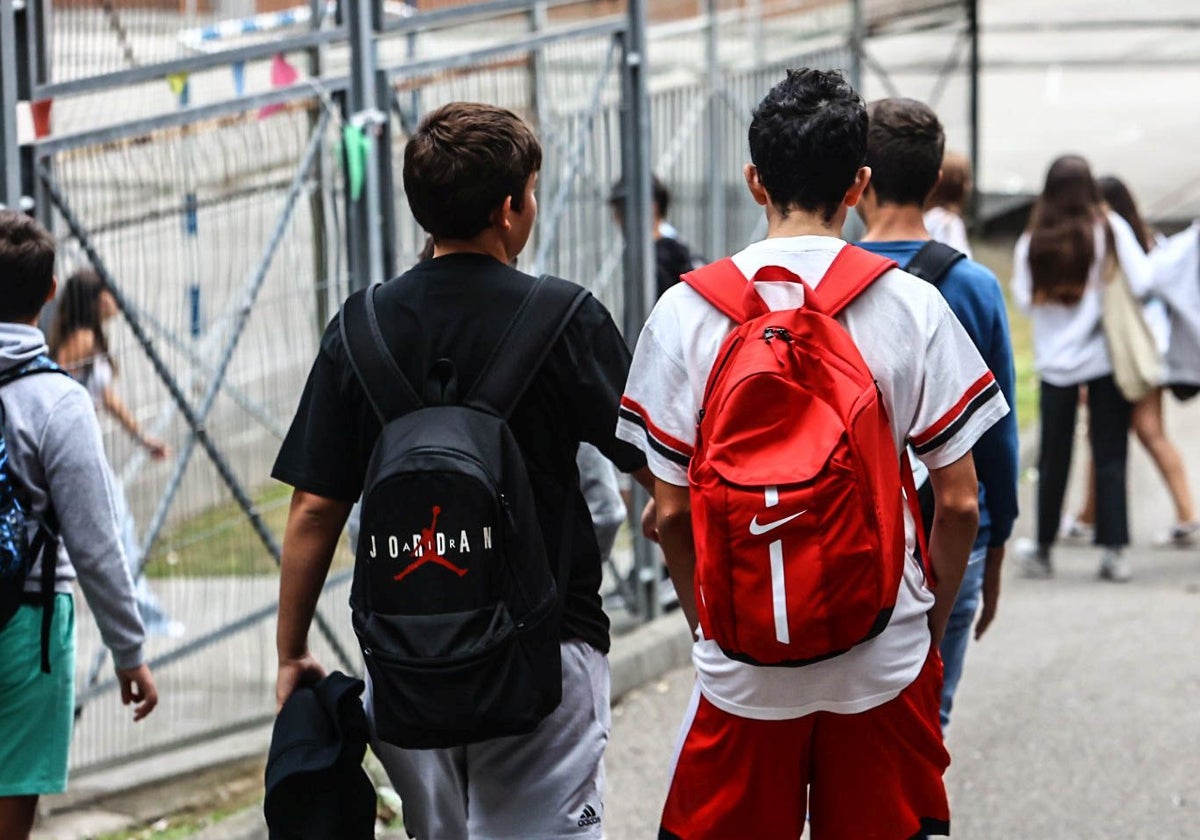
[274,103,648,838]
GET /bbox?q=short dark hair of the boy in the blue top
[866,98,946,206]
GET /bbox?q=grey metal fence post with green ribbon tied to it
[342,0,388,289]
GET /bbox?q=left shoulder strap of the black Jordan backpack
[338,284,424,424]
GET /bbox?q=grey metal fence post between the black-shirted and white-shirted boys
[620,0,660,618]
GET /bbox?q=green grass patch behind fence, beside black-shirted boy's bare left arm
[146,481,353,577]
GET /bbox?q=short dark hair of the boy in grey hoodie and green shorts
[0,210,54,320]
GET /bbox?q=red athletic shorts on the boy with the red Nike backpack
[659,650,950,840]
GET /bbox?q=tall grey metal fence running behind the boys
[0,0,964,770]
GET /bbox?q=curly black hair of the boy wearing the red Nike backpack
[750,70,866,222]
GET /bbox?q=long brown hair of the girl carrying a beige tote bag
[1027,155,1104,306]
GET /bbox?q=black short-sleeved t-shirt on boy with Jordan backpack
[271,253,646,653]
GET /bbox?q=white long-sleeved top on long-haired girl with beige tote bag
[1013,211,1153,388]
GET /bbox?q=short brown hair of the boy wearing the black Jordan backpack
[404,102,541,241]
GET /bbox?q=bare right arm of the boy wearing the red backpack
[929,452,979,647]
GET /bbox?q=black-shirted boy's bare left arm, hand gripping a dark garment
[275,490,353,712]
